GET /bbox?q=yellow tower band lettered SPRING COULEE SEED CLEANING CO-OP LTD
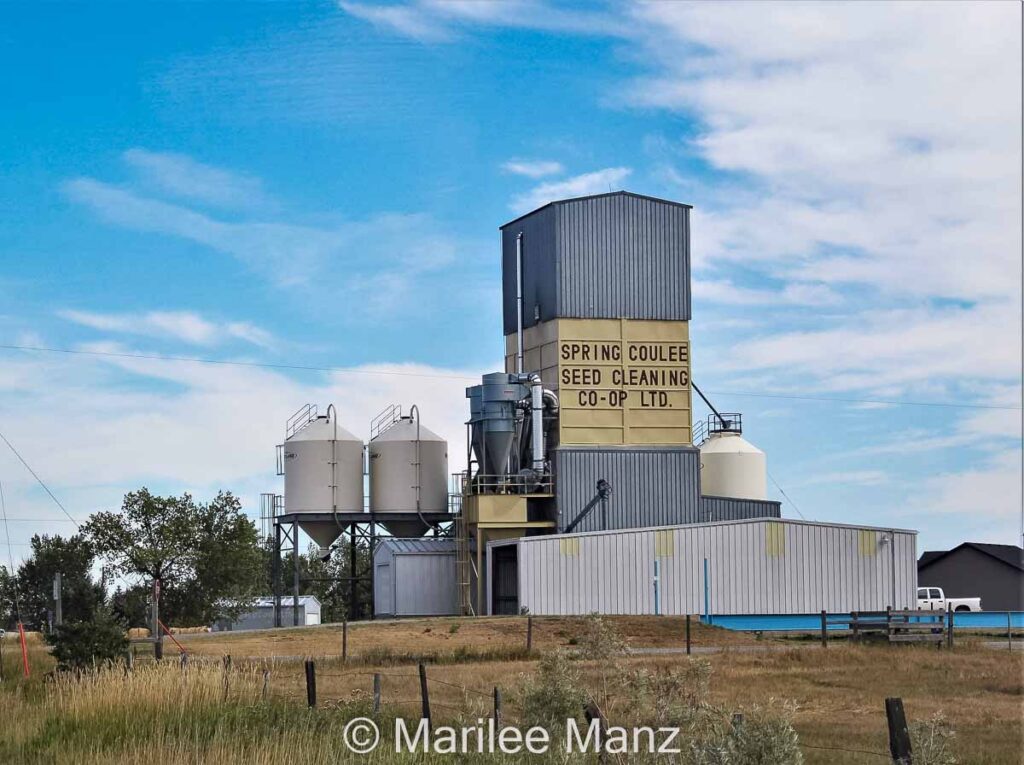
[506,318,691,445]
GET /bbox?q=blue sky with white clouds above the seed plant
[0,1,1021,554]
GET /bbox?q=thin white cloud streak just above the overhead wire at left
[57,309,273,347]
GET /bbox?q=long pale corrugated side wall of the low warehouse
[519,519,916,614]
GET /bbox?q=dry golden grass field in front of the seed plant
[0,618,1024,765]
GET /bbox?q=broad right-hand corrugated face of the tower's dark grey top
[556,195,690,320]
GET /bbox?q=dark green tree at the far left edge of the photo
[3,534,105,629]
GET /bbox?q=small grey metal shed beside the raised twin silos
[374,537,459,617]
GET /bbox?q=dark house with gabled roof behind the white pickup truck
[918,542,1024,611]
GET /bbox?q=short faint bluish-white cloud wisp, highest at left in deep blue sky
[123,148,266,208]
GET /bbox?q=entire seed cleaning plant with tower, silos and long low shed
[274,192,916,623]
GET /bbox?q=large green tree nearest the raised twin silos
[82,488,263,626]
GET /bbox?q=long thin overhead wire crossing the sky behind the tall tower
[0,344,1021,412]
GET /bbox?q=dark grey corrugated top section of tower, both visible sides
[502,193,690,335]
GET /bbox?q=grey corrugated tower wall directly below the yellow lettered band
[553,448,701,532]
